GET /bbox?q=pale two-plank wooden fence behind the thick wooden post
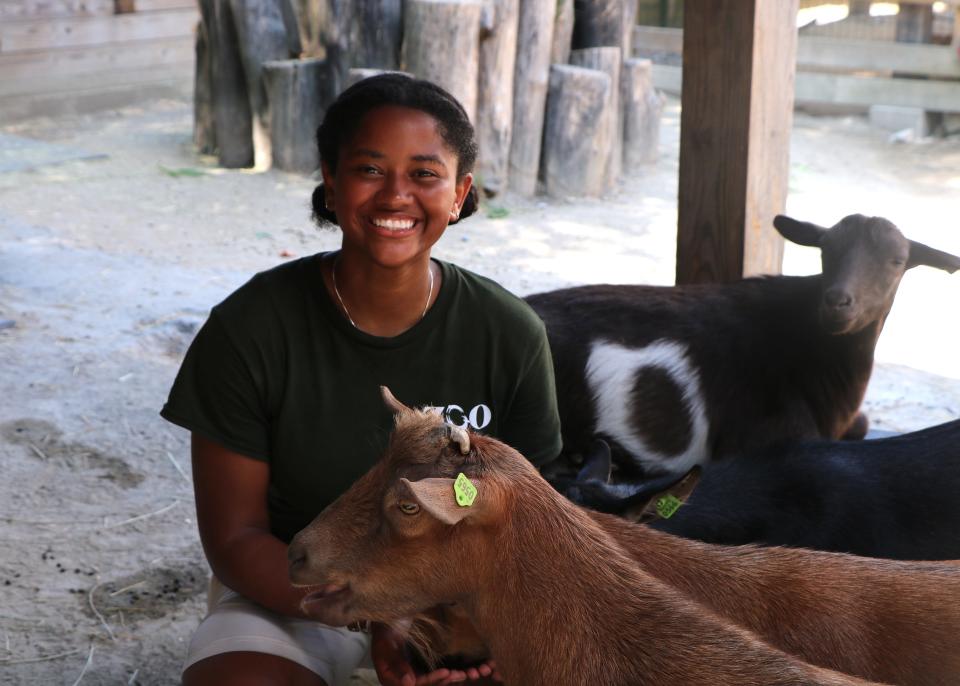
[633,26,960,112]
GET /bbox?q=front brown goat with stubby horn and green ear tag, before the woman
[289,391,880,686]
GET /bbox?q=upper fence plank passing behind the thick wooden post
[633,26,960,78]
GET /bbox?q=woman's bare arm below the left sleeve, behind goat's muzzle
[190,433,307,617]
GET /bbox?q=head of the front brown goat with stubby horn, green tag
[288,388,535,626]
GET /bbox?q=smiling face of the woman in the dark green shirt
[323,105,472,267]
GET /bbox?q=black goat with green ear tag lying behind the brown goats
[554,420,960,560]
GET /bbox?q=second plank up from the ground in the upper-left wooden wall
[0,37,194,88]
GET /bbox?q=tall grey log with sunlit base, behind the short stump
[230,0,290,169]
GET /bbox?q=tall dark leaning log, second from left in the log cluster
[200,0,253,169]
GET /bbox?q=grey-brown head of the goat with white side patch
[773,214,960,335]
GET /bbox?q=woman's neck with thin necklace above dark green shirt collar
[323,251,441,338]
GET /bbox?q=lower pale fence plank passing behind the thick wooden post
[653,64,960,112]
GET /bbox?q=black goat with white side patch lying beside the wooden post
[527,214,960,474]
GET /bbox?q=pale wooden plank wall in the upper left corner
[0,0,199,122]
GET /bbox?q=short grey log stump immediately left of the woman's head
[263,58,335,174]
